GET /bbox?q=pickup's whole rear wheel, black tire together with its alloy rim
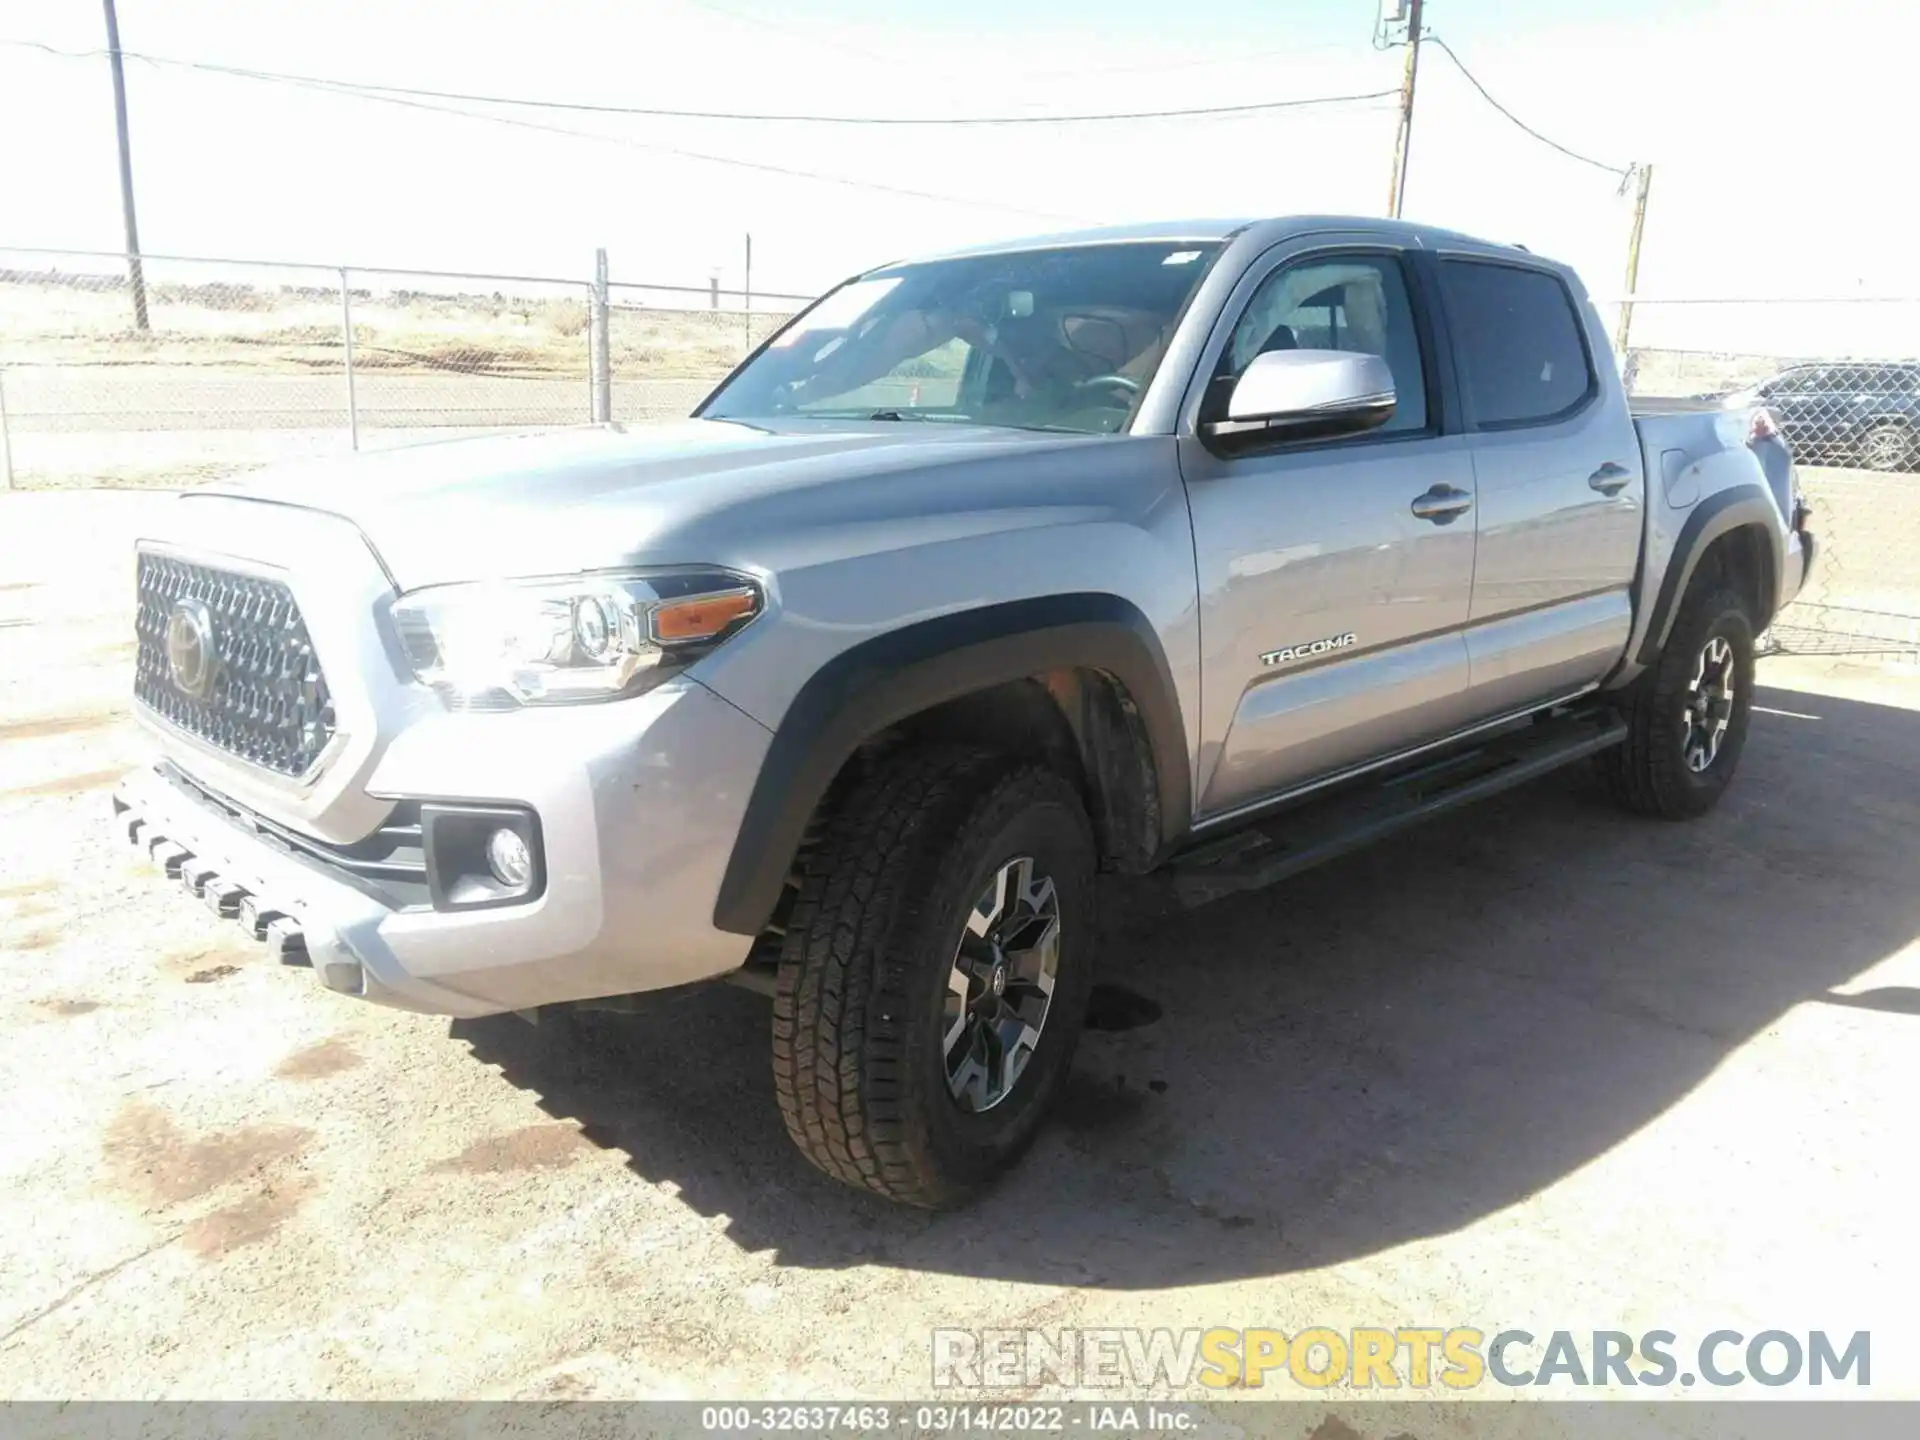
[1597,588,1753,820]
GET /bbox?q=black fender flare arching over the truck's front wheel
[714,593,1192,935]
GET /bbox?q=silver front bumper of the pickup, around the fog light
[113,678,772,1016]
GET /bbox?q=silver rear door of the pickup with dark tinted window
[1434,255,1645,720]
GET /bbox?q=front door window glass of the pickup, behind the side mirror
[1204,255,1427,434]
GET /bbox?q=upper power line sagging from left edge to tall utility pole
[8,40,1396,125]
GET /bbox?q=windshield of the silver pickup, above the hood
[701,240,1219,434]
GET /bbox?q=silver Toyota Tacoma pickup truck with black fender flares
[115,217,1812,1206]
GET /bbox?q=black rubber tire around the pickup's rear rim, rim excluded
[1596,582,1753,820]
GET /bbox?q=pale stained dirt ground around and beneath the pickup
[0,493,1920,1398]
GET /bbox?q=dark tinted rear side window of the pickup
[1440,259,1594,428]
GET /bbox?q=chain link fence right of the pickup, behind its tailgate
[1619,305,1920,659]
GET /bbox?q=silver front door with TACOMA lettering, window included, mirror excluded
[1179,242,1475,822]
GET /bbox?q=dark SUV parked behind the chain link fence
[1728,361,1920,470]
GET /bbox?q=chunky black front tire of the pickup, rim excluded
[774,745,1096,1210]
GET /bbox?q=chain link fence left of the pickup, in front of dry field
[0,248,804,488]
